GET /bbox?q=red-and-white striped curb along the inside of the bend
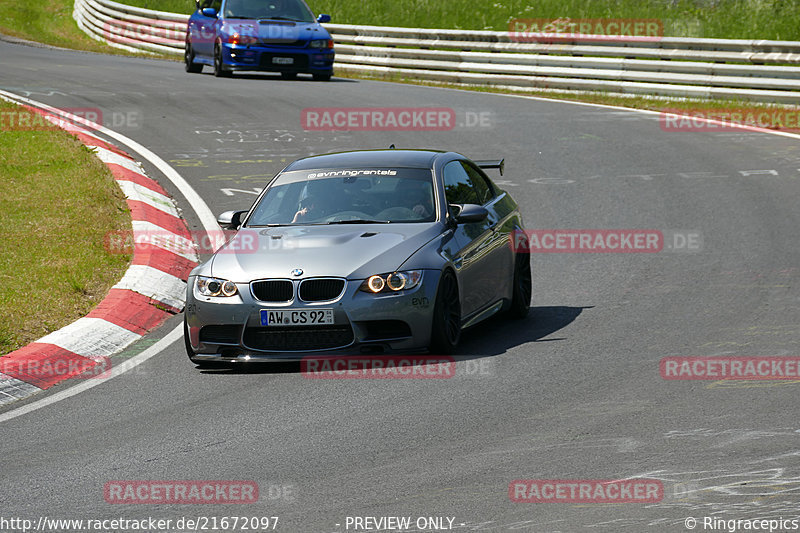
[0,106,198,405]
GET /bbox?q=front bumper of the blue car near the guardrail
[222,44,336,74]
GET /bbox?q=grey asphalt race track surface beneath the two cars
[0,43,800,533]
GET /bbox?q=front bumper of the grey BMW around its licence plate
[185,270,440,362]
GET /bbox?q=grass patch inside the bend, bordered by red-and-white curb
[0,101,131,354]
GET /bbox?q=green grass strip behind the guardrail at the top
[126,0,800,41]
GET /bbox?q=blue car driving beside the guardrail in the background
[184,0,334,81]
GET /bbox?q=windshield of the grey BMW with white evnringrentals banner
[247,168,436,223]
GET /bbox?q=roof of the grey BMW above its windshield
[286,149,444,172]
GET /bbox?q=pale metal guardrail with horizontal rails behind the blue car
[74,0,800,104]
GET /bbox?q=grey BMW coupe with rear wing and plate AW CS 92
[185,149,531,366]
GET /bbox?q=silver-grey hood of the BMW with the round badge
[211,223,442,283]
